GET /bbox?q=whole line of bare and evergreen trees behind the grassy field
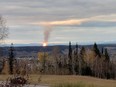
[2,42,116,79]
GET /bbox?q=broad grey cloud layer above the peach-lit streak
[0,0,116,25]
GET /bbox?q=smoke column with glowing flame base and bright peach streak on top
[39,19,88,47]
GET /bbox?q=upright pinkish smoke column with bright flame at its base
[43,25,52,46]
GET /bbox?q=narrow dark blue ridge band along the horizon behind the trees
[1,44,116,52]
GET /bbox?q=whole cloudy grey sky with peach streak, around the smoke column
[0,0,116,44]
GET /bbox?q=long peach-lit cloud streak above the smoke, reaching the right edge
[33,14,116,26]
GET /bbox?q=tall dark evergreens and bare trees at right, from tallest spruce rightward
[68,42,116,79]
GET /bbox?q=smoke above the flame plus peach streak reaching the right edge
[37,15,116,44]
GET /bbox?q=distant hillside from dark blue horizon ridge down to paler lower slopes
[1,44,116,58]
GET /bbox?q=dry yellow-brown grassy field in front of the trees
[0,75,116,87]
